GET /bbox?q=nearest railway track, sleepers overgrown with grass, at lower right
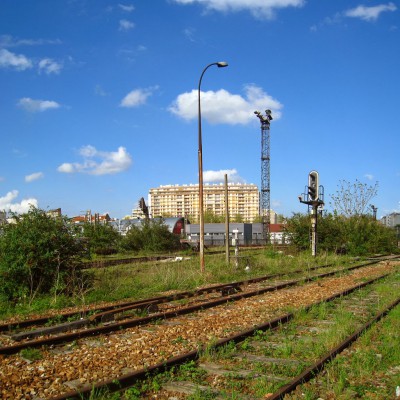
[52,268,400,400]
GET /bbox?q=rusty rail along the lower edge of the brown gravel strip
[50,274,390,400]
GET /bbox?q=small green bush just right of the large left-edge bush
[82,223,120,255]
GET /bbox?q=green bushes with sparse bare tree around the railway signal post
[285,180,398,256]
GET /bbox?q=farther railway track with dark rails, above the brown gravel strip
[0,259,396,354]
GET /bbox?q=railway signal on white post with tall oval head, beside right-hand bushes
[299,171,324,257]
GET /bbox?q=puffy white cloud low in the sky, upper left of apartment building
[57,145,132,175]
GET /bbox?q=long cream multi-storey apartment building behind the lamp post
[149,183,260,223]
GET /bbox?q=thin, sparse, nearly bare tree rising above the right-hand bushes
[331,179,378,217]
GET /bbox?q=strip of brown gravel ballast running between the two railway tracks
[0,260,393,399]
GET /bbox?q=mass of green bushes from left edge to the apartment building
[0,207,179,305]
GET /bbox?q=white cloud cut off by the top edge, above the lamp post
[170,0,305,19]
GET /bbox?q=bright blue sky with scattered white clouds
[0,0,400,218]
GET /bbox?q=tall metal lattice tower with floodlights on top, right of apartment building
[254,110,272,243]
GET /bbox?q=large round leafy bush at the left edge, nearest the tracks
[0,207,87,301]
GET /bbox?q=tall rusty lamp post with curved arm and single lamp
[197,61,228,273]
